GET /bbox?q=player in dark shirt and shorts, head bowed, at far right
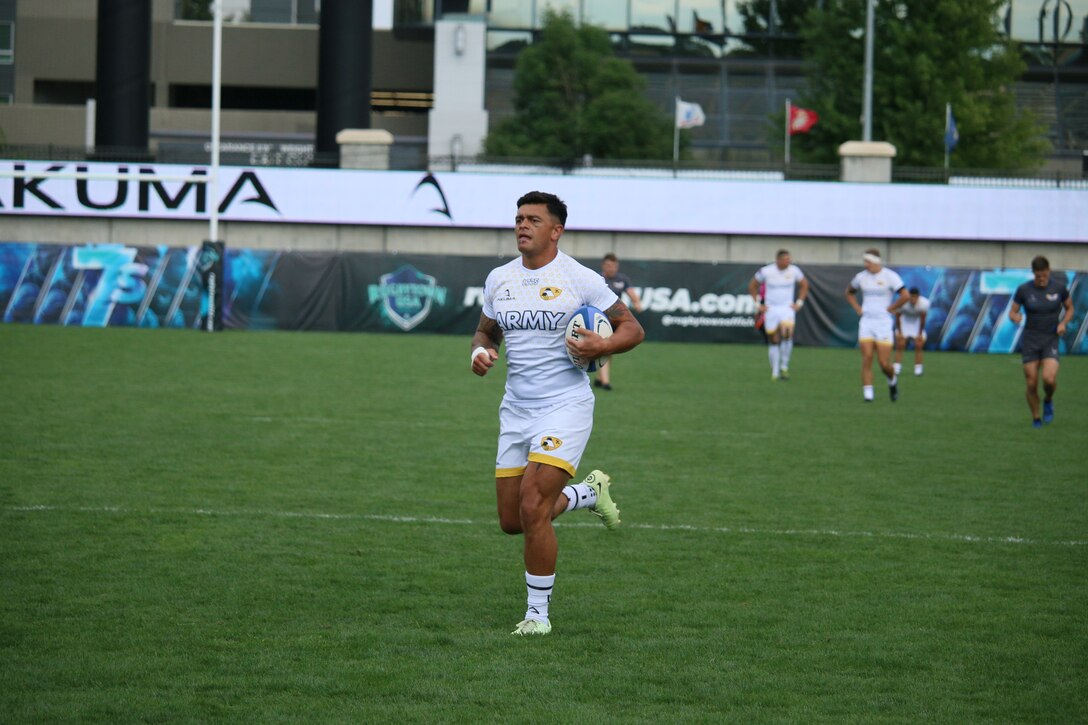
[1009,257,1073,428]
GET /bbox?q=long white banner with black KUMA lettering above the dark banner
[0,160,1088,242]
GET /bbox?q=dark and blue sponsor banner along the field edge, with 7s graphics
[0,244,1088,354]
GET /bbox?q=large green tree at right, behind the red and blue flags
[778,0,1049,169]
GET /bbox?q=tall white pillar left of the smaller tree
[426,15,487,168]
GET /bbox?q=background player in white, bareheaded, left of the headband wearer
[749,249,808,380]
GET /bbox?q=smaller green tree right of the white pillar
[485,11,672,162]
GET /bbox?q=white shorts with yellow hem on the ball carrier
[495,393,595,478]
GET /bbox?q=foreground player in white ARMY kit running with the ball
[471,192,644,635]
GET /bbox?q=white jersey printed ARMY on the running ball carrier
[483,251,619,407]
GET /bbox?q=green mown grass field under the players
[0,325,1088,723]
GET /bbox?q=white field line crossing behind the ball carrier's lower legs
[3,505,1088,546]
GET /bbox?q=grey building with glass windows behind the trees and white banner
[0,0,1088,173]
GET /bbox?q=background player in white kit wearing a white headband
[846,249,907,403]
